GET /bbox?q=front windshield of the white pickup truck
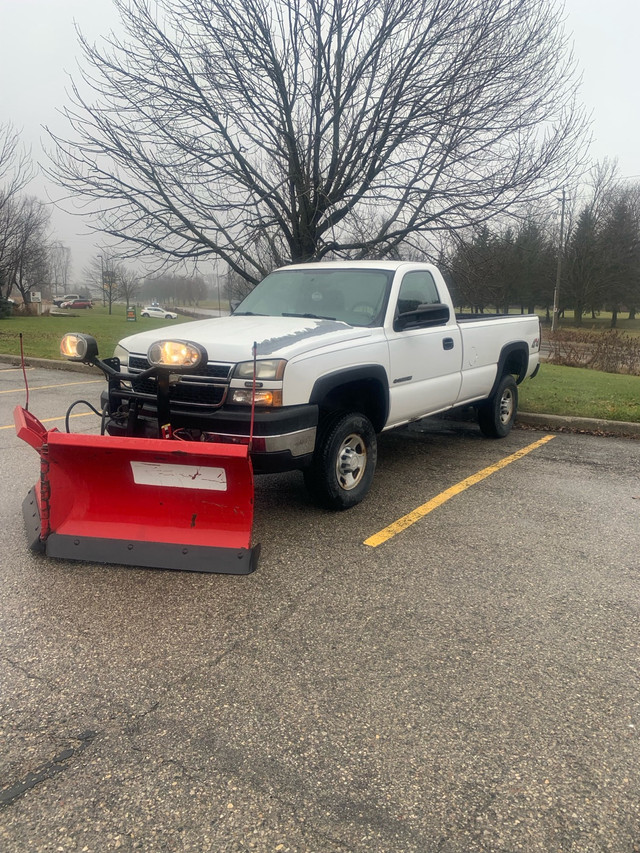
[233,268,393,326]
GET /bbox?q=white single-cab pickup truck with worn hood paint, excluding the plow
[103,261,540,509]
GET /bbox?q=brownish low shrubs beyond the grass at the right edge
[547,329,640,376]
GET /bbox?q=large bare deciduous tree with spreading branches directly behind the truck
[49,0,585,282]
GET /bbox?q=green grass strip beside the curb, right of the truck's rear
[518,364,640,423]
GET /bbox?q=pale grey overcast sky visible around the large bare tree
[0,0,640,278]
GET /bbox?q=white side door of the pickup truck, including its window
[387,270,462,425]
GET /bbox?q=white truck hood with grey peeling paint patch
[120,315,371,364]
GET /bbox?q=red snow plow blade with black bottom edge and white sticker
[15,407,259,574]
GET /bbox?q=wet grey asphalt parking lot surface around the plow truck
[0,365,640,853]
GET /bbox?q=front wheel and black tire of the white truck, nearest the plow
[304,412,378,510]
